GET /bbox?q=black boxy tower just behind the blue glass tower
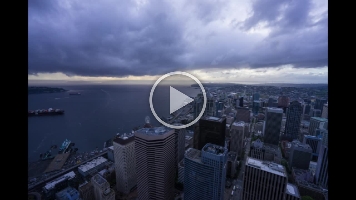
[194,116,226,150]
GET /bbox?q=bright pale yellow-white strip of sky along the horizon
[28,65,328,84]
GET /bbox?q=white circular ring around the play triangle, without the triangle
[149,71,207,129]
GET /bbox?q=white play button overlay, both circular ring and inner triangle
[149,71,207,129]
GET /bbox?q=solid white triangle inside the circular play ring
[169,86,194,114]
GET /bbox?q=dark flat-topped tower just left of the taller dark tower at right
[264,108,283,145]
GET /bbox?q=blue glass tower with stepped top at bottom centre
[184,143,227,200]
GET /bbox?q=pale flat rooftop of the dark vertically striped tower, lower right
[246,157,287,177]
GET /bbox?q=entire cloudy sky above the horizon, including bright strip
[28,0,328,83]
